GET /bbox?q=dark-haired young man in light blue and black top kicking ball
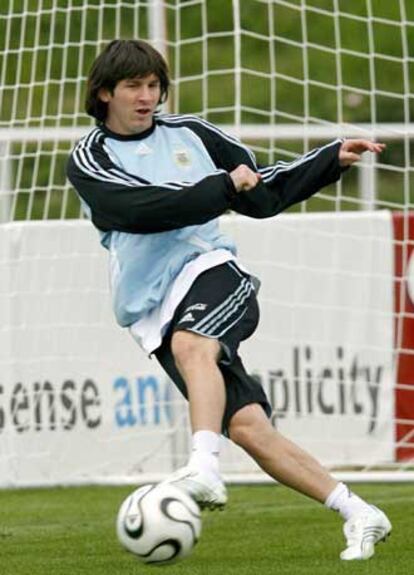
[68,40,391,560]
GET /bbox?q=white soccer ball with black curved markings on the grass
[116,483,201,563]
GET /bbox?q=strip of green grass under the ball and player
[0,484,414,575]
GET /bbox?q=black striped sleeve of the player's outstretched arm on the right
[184,120,343,218]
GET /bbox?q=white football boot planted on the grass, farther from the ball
[340,505,392,561]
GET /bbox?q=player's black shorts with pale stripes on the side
[154,262,271,434]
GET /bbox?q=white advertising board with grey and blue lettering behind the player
[0,213,394,486]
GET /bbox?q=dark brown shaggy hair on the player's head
[85,40,170,122]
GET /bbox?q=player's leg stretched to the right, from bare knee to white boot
[229,404,391,560]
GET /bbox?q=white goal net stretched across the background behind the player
[0,0,414,486]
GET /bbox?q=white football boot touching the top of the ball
[162,466,227,509]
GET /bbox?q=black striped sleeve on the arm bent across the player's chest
[67,132,235,233]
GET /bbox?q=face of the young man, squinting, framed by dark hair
[99,74,161,136]
